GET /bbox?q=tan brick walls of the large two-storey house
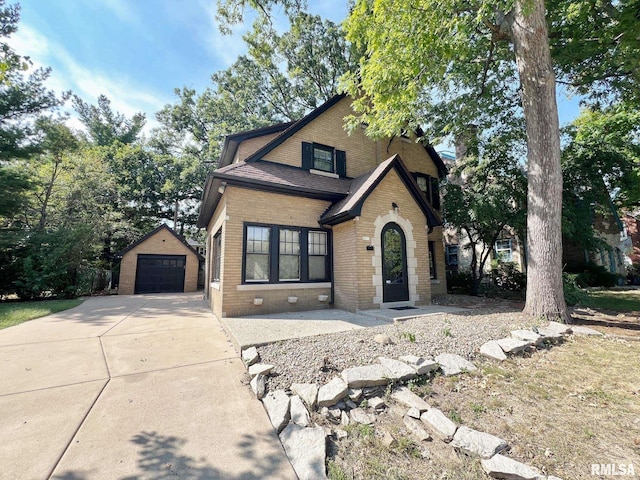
[202,98,446,317]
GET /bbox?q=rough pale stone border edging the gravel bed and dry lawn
[242,322,602,480]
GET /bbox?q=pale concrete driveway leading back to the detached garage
[0,294,295,480]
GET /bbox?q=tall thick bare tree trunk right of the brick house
[511,0,569,322]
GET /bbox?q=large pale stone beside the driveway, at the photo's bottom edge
[280,423,327,480]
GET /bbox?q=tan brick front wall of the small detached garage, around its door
[118,229,200,295]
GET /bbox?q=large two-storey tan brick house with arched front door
[198,95,446,317]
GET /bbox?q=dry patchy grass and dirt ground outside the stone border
[318,297,640,480]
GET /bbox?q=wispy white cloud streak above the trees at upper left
[10,24,166,130]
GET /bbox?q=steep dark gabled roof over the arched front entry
[319,155,442,227]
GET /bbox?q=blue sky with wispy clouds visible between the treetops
[8,0,578,134]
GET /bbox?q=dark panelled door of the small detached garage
[134,255,187,293]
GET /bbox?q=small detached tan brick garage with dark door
[118,225,203,295]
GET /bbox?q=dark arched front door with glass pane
[381,222,409,302]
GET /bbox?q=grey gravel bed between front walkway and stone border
[258,295,535,390]
